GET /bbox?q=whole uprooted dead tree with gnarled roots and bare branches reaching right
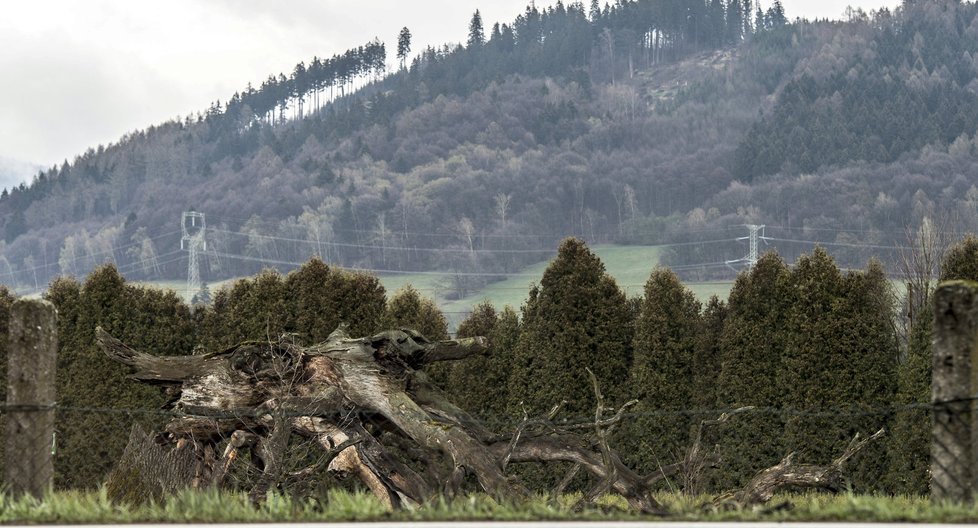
[96,326,881,513]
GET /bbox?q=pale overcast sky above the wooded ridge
[0,0,900,172]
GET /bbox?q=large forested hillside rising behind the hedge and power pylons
[0,0,978,290]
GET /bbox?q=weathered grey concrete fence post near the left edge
[4,299,58,497]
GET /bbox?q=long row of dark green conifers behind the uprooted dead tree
[0,238,960,493]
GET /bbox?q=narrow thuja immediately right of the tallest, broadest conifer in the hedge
[623,269,700,471]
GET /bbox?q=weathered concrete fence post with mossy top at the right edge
[931,281,978,502]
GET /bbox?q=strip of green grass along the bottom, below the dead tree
[0,491,978,524]
